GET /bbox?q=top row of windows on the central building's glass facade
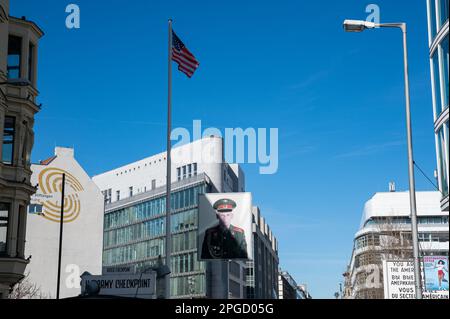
[104,184,205,230]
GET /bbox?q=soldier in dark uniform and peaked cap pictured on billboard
[201,199,248,259]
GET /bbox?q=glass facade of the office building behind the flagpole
[103,182,206,297]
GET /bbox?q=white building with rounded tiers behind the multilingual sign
[344,188,449,299]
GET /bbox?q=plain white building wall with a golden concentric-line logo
[24,147,104,298]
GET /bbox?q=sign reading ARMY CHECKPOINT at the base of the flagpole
[81,272,156,299]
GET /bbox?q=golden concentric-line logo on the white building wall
[28,167,84,223]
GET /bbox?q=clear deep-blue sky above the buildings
[11,0,436,298]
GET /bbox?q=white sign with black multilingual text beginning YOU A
[383,260,416,299]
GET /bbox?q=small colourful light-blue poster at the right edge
[423,256,449,291]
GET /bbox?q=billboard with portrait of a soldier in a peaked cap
[197,193,253,260]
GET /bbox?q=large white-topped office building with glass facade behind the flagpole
[93,136,253,298]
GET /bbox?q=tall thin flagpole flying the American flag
[165,19,172,299]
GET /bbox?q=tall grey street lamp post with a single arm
[344,20,422,299]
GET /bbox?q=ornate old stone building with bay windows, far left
[0,0,43,298]
